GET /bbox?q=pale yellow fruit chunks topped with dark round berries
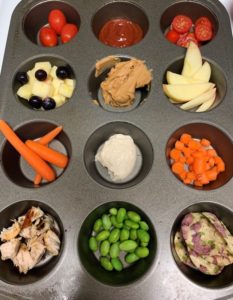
[16,61,75,110]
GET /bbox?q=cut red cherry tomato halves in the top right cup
[165,15,214,48]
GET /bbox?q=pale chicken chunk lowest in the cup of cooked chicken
[13,243,34,274]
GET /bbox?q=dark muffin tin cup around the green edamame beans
[78,201,157,286]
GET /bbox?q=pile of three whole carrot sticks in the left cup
[0,120,69,185]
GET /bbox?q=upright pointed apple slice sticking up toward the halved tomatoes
[181,42,202,77]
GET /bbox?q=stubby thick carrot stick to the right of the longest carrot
[25,140,68,168]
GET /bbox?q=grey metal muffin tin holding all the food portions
[0,0,233,300]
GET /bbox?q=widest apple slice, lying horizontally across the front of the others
[163,82,215,102]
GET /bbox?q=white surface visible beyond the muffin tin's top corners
[0,0,233,72]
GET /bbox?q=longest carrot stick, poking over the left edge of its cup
[0,120,55,181]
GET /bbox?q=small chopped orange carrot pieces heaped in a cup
[169,133,225,187]
